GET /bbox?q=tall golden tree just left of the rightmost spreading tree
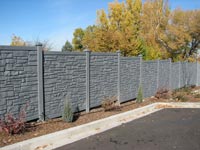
[141,0,170,60]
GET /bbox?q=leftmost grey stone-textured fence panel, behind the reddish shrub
[0,46,38,120]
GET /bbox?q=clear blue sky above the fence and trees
[0,0,200,50]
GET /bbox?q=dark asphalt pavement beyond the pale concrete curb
[57,108,200,150]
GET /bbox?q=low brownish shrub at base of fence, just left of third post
[101,96,119,111]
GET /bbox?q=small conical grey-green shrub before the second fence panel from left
[62,97,74,123]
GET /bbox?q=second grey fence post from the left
[84,49,90,113]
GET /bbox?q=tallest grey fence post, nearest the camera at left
[36,43,45,121]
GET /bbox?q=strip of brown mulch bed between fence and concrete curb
[0,87,200,147]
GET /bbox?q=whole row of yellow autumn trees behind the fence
[73,0,200,61]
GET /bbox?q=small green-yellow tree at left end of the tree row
[72,28,84,51]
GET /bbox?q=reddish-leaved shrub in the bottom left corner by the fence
[0,105,27,134]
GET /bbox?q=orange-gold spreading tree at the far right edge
[165,9,200,60]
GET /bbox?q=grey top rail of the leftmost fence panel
[0,45,37,51]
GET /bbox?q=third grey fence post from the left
[117,50,121,104]
